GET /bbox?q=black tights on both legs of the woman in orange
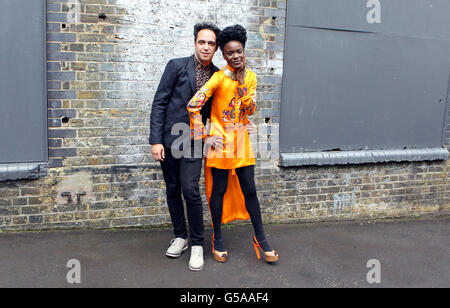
[210,166,271,251]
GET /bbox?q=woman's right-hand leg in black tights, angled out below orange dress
[236,166,272,251]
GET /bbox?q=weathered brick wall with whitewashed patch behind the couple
[0,0,450,230]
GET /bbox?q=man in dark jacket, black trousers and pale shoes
[150,23,220,271]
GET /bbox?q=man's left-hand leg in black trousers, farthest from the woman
[161,147,188,239]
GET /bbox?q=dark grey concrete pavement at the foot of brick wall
[0,218,450,288]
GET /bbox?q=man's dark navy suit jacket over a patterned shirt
[150,56,219,147]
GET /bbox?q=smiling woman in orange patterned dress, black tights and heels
[187,25,279,263]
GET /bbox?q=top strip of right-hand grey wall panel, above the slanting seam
[288,0,450,39]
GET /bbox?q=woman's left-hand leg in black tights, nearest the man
[209,168,228,251]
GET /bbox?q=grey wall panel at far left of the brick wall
[0,0,48,163]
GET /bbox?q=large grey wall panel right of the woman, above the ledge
[280,0,450,153]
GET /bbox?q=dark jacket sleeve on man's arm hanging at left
[150,60,178,144]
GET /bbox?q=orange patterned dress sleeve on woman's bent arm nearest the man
[187,72,220,140]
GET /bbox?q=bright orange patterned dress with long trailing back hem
[187,65,257,224]
